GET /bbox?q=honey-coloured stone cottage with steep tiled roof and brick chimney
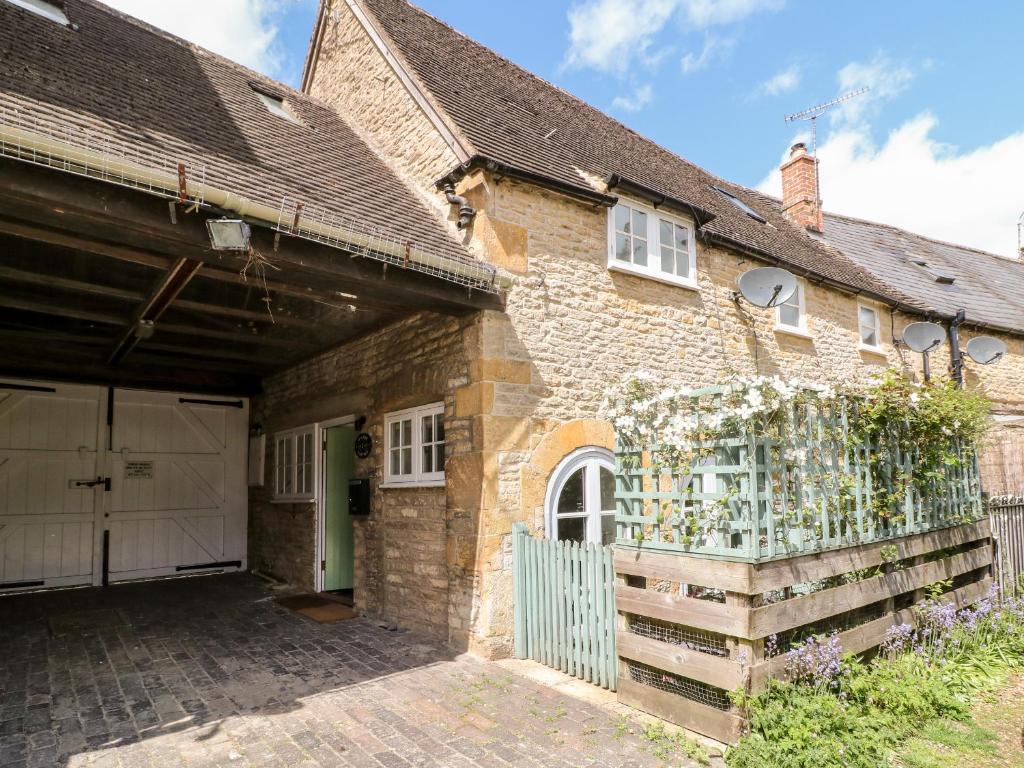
[243,0,1024,655]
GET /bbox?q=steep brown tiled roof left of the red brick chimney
[346,0,918,307]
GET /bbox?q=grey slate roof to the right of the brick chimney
[824,213,1024,333]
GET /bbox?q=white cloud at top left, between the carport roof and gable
[103,0,282,76]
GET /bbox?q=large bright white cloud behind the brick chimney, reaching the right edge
[759,113,1024,256]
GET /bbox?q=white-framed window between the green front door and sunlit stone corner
[384,402,444,487]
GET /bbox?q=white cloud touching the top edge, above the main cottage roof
[565,0,783,72]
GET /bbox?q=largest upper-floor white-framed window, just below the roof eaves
[608,201,696,288]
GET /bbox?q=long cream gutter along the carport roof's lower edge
[0,124,512,289]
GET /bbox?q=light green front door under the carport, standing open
[324,427,355,591]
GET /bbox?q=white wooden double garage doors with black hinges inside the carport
[0,381,248,591]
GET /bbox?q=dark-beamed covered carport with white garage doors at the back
[0,107,502,594]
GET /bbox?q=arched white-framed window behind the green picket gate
[544,447,615,544]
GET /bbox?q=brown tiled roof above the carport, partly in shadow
[0,0,472,268]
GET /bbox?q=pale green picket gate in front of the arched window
[512,523,617,690]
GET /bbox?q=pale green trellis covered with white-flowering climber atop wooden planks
[615,387,984,562]
